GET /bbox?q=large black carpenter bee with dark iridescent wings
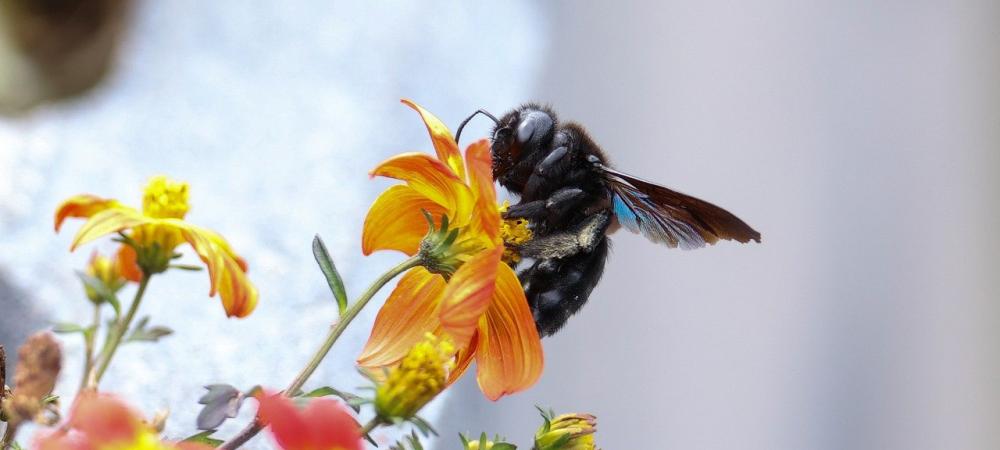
[456,104,760,336]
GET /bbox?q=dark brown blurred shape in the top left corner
[0,0,132,114]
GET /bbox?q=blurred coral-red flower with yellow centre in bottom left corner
[34,392,211,450]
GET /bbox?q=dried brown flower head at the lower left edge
[3,332,62,424]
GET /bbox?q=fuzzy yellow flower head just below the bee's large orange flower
[375,333,455,421]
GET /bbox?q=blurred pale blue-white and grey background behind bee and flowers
[0,0,1000,450]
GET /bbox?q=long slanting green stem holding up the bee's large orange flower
[218,256,420,450]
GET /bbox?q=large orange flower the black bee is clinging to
[358,100,543,400]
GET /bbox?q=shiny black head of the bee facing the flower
[490,105,556,187]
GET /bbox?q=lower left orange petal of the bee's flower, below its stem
[358,267,445,368]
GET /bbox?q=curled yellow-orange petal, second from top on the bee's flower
[371,153,474,226]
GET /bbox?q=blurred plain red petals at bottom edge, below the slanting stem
[257,394,362,450]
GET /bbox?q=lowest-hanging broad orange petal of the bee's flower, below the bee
[476,264,544,400]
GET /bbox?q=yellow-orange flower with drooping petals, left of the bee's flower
[55,176,258,317]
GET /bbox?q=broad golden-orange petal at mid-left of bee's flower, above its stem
[361,185,445,256]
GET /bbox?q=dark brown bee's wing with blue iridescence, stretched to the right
[597,164,760,249]
